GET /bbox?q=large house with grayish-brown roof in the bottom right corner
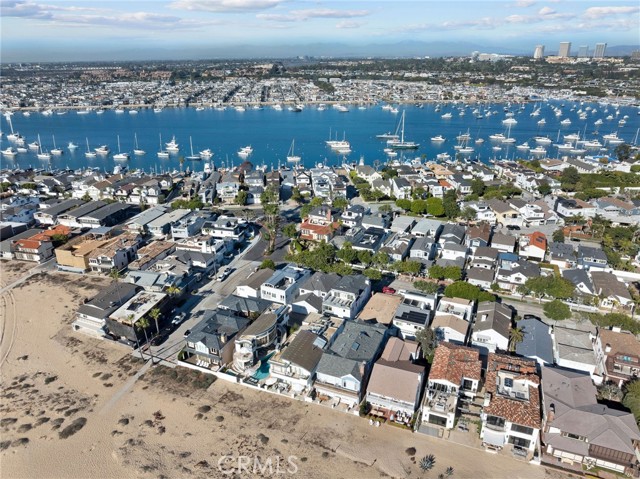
[542,368,640,476]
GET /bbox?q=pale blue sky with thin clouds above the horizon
[0,0,640,62]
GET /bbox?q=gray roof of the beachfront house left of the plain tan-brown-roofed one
[329,321,387,362]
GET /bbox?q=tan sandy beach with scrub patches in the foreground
[0,262,562,479]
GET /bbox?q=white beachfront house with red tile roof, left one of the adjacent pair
[422,342,482,429]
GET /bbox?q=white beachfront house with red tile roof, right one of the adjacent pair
[480,353,542,458]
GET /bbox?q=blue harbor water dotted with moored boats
[1,101,640,171]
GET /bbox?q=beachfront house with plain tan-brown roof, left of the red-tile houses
[366,338,425,424]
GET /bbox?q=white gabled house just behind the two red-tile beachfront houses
[470,301,513,356]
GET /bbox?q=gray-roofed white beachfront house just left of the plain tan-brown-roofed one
[314,321,388,408]
